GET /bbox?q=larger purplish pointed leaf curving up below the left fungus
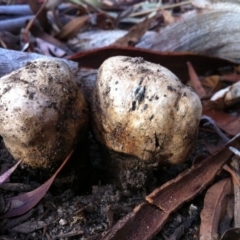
[0,151,73,219]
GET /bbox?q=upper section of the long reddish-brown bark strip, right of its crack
[146,134,240,212]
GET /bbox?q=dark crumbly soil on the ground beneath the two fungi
[0,129,216,240]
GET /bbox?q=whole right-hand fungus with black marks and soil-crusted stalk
[91,56,202,188]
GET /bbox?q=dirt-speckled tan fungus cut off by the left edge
[0,59,88,168]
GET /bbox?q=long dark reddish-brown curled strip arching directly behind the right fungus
[67,46,233,82]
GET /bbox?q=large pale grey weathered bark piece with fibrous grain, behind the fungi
[137,2,240,61]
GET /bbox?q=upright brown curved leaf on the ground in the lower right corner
[199,178,232,240]
